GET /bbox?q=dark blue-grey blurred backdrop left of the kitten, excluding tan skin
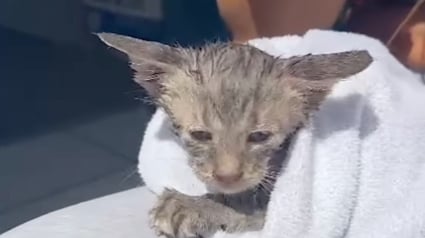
[0,0,228,233]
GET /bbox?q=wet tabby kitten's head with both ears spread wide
[100,33,372,193]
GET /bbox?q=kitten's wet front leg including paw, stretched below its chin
[150,190,264,238]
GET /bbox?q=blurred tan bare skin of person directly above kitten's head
[217,0,346,42]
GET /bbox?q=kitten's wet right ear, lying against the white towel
[284,50,373,109]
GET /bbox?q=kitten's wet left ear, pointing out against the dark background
[97,33,181,98]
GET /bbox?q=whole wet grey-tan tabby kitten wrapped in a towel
[99,33,372,238]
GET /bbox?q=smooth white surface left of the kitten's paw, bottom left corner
[0,187,155,238]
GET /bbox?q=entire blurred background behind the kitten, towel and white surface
[0,0,425,234]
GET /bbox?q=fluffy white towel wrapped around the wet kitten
[139,30,425,238]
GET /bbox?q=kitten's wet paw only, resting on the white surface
[149,190,220,238]
